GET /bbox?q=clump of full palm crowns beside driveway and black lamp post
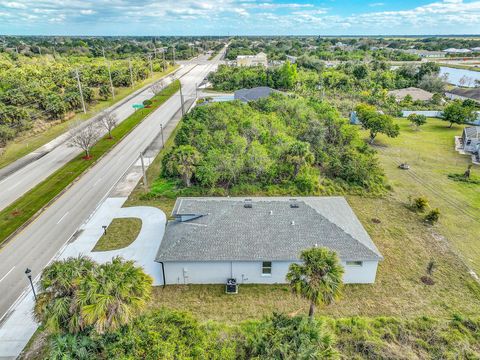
[35,257,152,334]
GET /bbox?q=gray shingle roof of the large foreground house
[156,197,382,262]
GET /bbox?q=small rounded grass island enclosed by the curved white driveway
[92,218,142,251]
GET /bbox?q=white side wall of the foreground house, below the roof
[158,261,378,285]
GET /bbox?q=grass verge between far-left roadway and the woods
[0,67,176,168]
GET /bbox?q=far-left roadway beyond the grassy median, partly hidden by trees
[0,63,195,210]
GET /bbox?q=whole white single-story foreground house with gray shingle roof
[156,197,383,284]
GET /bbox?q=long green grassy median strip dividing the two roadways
[0,81,180,244]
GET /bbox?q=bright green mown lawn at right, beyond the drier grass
[370,119,480,274]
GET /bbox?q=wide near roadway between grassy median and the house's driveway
[0,49,222,319]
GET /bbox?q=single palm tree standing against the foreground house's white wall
[287,247,344,319]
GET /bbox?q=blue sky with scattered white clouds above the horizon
[0,0,480,35]
